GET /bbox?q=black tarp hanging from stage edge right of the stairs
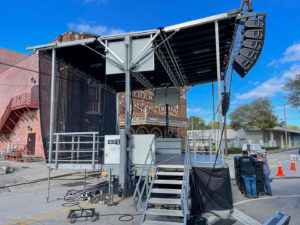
[190,167,233,215]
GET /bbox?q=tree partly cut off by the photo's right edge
[283,74,300,108]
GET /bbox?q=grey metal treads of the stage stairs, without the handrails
[140,165,184,225]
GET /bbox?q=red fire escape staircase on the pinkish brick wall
[0,93,39,142]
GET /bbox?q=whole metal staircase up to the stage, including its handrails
[133,136,191,225]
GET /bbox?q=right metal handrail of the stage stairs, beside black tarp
[181,136,192,225]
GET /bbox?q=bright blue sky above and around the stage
[0,0,300,126]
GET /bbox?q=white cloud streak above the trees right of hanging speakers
[236,65,300,100]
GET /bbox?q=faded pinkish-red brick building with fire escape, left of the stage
[0,30,101,158]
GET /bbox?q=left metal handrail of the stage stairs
[132,138,155,210]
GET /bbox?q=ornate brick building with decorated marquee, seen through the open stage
[119,89,187,137]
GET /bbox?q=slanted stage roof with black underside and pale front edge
[28,10,240,92]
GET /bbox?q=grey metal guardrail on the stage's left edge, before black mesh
[48,132,104,169]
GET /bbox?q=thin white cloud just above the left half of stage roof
[68,22,125,35]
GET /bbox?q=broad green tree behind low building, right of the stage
[229,98,278,130]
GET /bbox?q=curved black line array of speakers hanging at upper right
[232,14,266,77]
